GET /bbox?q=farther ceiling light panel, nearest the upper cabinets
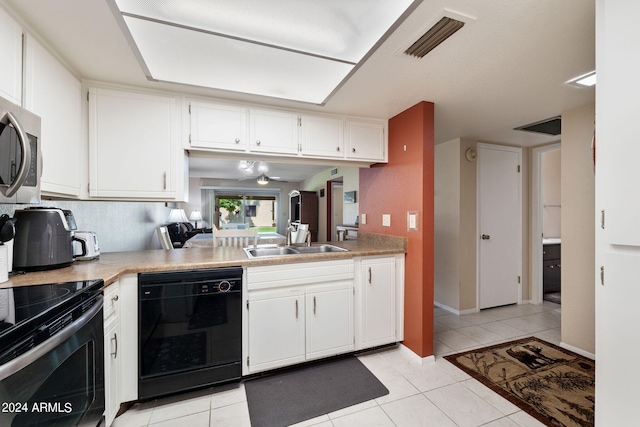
[125,18,353,104]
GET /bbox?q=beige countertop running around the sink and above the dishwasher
[0,233,406,288]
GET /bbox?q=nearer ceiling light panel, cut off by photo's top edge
[116,0,413,62]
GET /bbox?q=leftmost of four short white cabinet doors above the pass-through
[190,102,247,151]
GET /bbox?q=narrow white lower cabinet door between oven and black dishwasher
[104,316,120,426]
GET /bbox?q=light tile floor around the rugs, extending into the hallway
[113,301,560,427]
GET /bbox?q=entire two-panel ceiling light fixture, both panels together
[110,0,421,103]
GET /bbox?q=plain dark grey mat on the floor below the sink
[244,357,389,427]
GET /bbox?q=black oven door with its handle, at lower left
[0,296,104,427]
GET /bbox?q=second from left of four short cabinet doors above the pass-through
[249,109,298,154]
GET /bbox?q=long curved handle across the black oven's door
[0,295,103,381]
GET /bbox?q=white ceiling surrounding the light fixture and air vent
[0,0,595,182]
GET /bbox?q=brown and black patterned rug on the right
[445,337,595,426]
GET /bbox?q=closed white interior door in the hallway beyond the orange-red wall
[477,144,522,309]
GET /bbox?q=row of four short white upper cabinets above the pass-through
[185,101,387,163]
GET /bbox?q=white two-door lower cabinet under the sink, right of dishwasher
[244,259,354,374]
